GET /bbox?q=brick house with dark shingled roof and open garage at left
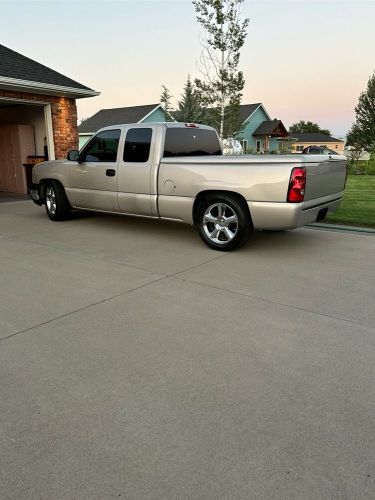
[0,45,99,193]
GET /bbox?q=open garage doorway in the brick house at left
[0,99,54,196]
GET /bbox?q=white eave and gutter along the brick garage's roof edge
[0,76,100,99]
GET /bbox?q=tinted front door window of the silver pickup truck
[80,129,121,162]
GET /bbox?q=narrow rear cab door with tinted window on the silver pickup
[117,123,160,216]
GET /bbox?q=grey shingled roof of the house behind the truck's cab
[78,103,165,133]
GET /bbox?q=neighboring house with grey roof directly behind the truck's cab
[78,104,173,149]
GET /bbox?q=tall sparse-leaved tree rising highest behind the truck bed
[193,0,249,137]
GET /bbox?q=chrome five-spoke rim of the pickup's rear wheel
[203,203,238,245]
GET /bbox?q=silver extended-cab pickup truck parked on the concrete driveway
[31,123,346,251]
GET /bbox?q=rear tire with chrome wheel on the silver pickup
[197,194,254,252]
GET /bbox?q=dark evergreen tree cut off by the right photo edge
[347,73,375,153]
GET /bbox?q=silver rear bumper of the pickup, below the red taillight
[248,196,341,230]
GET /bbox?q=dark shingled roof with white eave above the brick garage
[0,44,99,97]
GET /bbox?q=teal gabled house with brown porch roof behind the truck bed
[236,102,289,153]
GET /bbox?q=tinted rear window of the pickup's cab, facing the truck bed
[163,128,222,158]
